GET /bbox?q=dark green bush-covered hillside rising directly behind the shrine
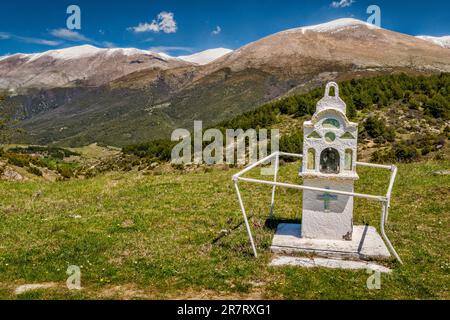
[124,74,450,162]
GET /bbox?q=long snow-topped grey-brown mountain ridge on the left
[0,45,189,91]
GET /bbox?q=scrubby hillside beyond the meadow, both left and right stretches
[0,74,450,180]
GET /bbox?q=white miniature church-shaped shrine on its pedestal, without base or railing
[301,82,358,240]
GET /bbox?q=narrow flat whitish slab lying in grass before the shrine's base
[269,256,392,273]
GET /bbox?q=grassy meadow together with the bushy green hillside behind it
[0,74,450,300]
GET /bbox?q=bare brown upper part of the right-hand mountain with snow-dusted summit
[204,19,450,75]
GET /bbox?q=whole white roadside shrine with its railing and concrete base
[233,82,401,268]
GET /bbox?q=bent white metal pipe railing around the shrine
[233,152,403,264]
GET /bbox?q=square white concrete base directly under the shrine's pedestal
[271,224,391,260]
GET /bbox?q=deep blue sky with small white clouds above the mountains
[0,0,450,55]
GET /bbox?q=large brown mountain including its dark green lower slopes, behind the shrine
[0,19,450,146]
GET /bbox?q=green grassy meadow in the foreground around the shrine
[0,161,450,299]
